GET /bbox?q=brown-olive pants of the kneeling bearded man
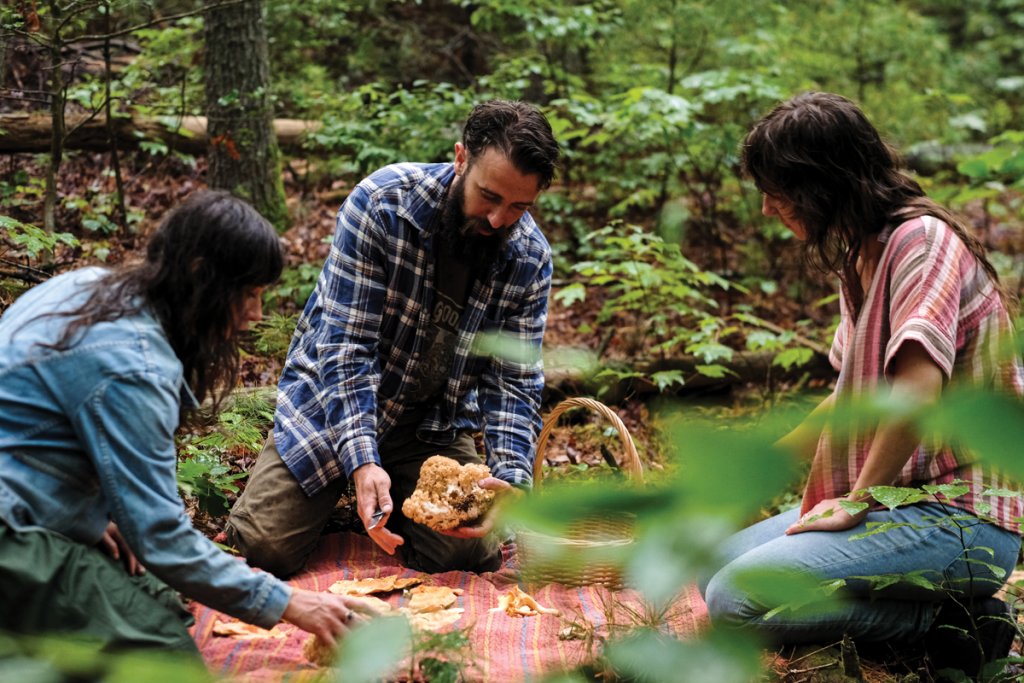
[230,430,502,578]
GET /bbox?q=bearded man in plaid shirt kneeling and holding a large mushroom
[225,100,559,577]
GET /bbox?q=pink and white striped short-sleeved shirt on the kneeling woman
[802,216,1024,532]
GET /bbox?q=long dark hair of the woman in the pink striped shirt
[740,92,1013,309]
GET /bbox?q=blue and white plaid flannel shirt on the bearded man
[273,164,551,496]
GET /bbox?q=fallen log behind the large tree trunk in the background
[0,113,321,155]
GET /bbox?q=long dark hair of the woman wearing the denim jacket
[54,190,284,420]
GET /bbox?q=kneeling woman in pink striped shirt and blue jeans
[701,92,1024,675]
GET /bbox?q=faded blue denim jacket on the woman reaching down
[0,268,291,628]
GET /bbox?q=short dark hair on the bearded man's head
[462,99,560,189]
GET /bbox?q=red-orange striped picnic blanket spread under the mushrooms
[191,533,707,683]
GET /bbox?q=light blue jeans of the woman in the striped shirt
[700,503,1021,645]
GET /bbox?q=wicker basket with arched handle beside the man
[516,398,643,589]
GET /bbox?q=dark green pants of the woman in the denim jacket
[0,520,199,657]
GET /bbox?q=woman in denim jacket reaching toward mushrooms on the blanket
[0,191,376,653]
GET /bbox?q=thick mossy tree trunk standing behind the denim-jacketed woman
[204,0,288,230]
